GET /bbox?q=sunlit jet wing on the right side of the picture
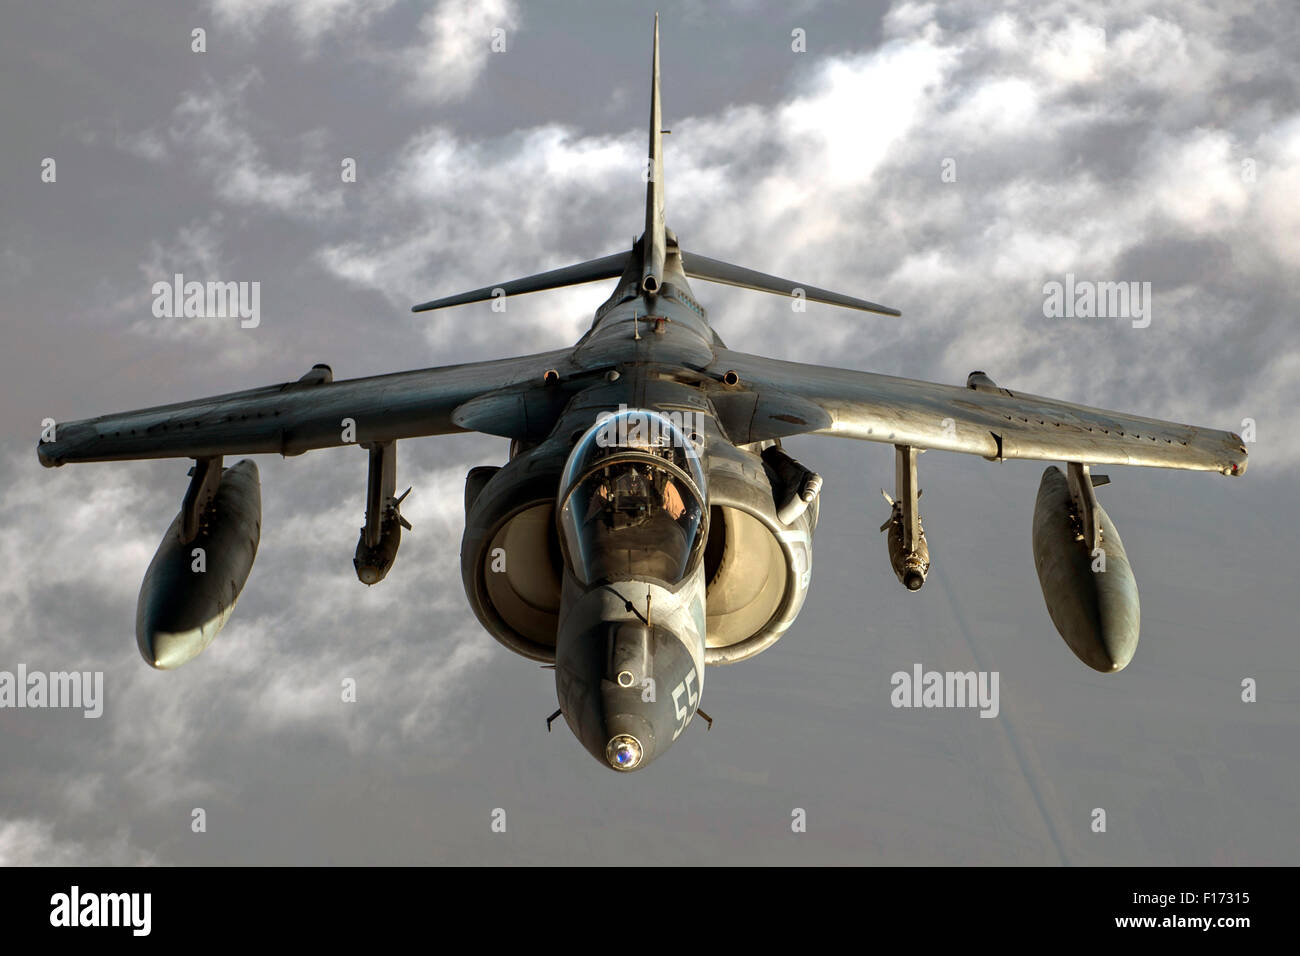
[714,349,1247,475]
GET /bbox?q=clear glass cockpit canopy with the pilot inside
[559,408,709,585]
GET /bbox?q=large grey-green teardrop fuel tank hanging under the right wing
[1034,466,1141,674]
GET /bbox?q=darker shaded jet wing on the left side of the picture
[38,349,571,467]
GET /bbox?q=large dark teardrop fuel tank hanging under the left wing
[135,458,261,670]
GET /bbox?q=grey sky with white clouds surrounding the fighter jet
[0,0,1300,865]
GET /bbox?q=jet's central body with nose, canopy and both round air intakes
[462,243,815,770]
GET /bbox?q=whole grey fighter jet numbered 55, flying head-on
[38,17,1247,771]
